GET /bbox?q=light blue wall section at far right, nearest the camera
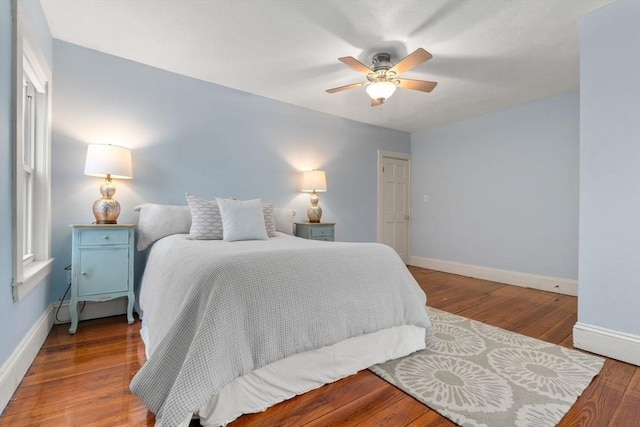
[578,0,640,336]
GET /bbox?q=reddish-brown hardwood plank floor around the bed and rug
[0,267,640,427]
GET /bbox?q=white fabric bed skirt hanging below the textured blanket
[140,320,425,427]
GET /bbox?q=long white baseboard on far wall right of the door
[410,256,578,296]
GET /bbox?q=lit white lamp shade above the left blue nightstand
[84,144,133,179]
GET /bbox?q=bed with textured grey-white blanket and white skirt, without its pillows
[131,201,430,426]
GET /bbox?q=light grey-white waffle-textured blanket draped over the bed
[131,235,430,426]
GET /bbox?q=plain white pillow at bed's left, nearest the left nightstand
[134,203,191,251]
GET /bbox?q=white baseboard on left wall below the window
[0,306,53,413]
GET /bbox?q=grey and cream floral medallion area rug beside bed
[369,307,604,427]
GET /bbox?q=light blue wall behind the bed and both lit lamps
[52,41,410,300]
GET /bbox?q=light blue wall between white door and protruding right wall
[411,92,579,279]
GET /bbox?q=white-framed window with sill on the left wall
[12,10,53,301]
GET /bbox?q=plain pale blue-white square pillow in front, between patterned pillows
[216,197,269,242]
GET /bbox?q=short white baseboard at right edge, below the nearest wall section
[573,322,640,366]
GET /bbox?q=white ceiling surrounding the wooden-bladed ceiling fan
[41,0,613,132]
